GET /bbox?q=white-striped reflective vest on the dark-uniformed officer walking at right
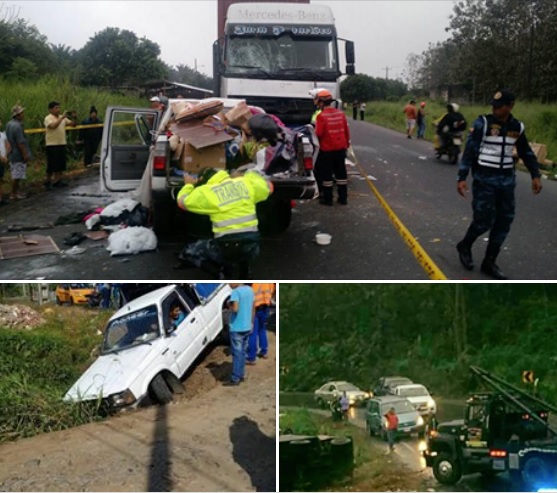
[478,115,524,169]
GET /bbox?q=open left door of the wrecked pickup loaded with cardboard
[101,106,161,192]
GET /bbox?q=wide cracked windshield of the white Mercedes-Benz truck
[226,34,338,76]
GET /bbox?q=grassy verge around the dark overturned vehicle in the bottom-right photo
[280,409,426,491]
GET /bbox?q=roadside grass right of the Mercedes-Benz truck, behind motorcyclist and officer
[354,100,557,171]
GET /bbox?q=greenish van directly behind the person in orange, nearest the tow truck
[366,395,425,440]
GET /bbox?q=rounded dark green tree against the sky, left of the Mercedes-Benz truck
[79,27,167,87]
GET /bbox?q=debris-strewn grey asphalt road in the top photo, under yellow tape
[0,120,557,280]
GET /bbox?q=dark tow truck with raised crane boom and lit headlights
[423,366,557,491]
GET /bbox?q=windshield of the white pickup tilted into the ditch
[102,305,160,354]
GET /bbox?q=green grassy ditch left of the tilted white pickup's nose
[0,306,112,442]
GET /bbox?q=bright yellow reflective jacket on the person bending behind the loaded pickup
[177,170,273,238]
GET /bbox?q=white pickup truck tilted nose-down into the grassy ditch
[64,283,231,408]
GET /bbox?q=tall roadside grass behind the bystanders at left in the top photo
[0,76,144,194]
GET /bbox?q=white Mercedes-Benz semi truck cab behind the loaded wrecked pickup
[213,0,355,124]
